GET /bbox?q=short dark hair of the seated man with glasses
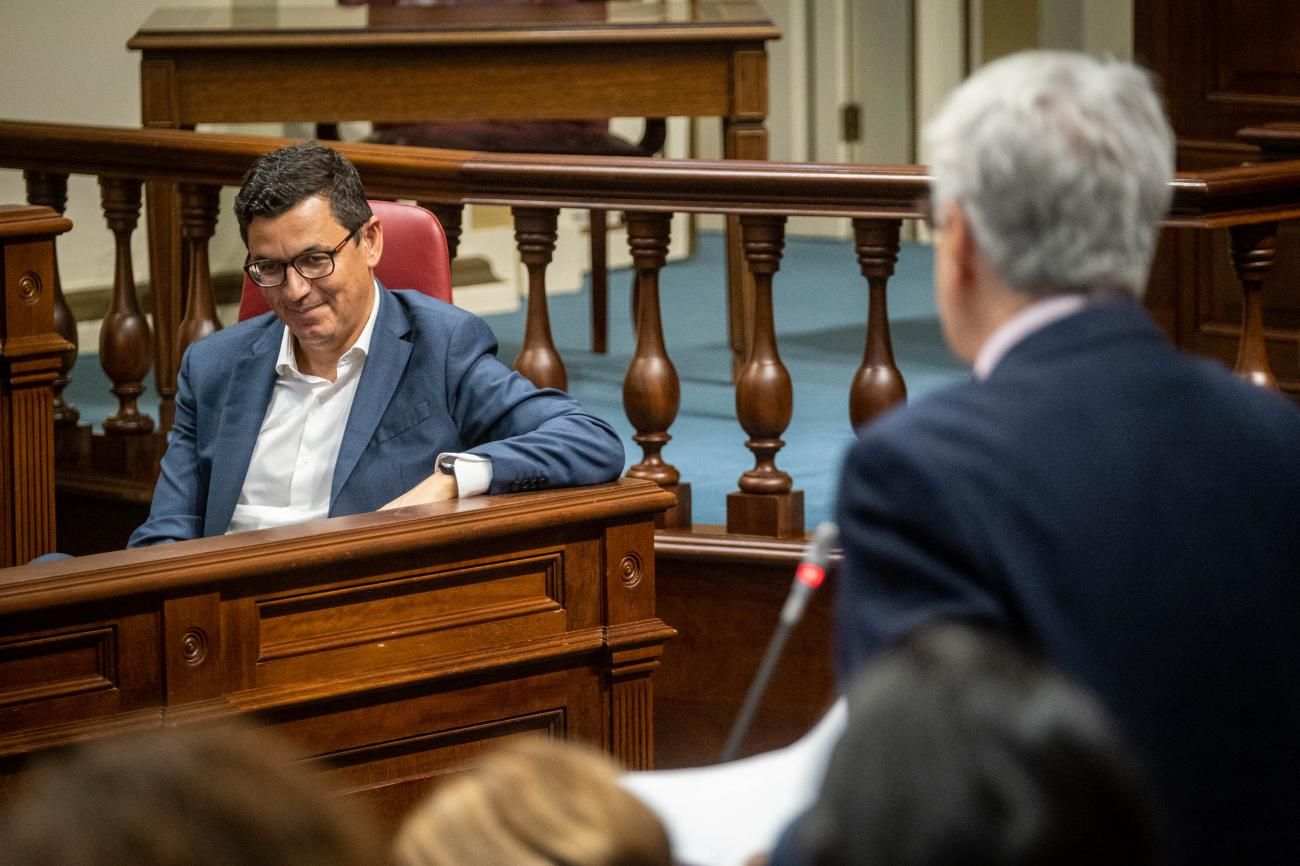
[235,142,371,244]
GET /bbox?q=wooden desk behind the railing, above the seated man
[127,0,780,426]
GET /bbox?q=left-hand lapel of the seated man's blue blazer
[204,320,285,536]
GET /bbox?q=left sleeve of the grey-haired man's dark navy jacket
[835,428,1009,684]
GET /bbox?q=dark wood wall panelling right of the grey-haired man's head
[1134,0,1300,399]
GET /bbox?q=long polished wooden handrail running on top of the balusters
[0,121,1300,228]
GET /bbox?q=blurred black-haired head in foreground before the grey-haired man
[796,625,1162,866]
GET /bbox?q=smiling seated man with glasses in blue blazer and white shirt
[130,142,623,547]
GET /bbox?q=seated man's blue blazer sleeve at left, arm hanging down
[126,351,208,547]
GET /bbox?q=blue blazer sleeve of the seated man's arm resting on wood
[446,310,623,493]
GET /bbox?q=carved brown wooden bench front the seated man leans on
[0,481,673,822]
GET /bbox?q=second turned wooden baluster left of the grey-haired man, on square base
[727,215,803,538]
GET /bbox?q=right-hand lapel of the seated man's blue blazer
[329,286,411,515]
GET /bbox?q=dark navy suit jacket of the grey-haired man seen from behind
[836,302,1300,865]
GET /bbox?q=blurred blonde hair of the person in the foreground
[393,737,672,866]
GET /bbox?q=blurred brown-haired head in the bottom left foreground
[0,726,382,866]
